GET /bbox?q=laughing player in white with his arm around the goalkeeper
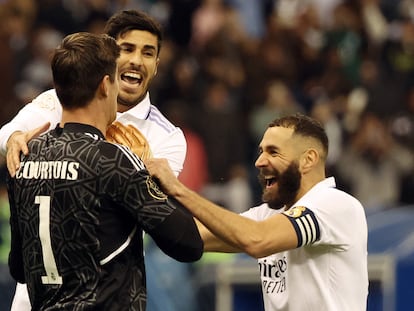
[0,10,187,311]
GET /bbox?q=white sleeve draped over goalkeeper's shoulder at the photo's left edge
[0,89,62,155]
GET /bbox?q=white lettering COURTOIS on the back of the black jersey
[16,161,79,180]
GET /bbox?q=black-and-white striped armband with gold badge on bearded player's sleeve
[283,206,321,247]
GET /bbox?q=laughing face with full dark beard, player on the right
[256,127,302,209]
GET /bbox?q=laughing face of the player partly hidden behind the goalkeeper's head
[116,30,159,112]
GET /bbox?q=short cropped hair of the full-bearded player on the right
[269,113,329,156]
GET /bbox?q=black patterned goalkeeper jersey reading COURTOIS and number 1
[8,123,203,311]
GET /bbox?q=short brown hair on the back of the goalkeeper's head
[51,32,120,108]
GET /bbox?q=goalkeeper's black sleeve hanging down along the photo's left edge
[7,176,26,283]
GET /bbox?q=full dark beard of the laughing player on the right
[259,161,302,209]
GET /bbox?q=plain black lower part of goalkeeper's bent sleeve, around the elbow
[148,202,204,262]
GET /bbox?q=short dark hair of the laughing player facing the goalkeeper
[104,10,163,55]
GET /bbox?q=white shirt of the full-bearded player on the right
[242,177,368,311]
